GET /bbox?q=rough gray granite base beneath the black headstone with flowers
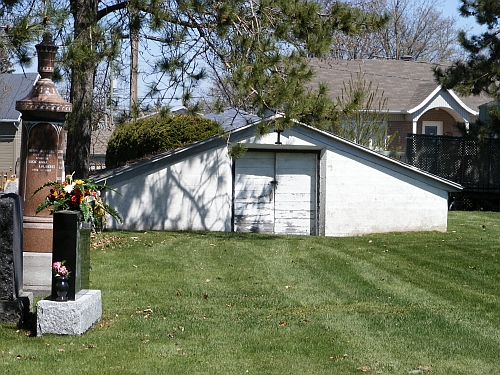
[36,290,102,336]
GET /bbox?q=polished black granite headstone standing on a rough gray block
[52,211,91,300]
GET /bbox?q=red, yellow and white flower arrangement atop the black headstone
[30,174,122,229]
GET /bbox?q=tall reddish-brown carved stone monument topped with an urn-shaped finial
[16,34,72,253]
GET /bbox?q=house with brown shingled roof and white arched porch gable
[310,59,491,151]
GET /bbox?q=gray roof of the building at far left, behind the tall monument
[0,73,39,123]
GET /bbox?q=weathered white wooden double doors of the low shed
[234,152,317,235]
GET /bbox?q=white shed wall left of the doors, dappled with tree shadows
[106,148,232,231]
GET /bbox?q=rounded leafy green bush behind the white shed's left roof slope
[106,116,224,168]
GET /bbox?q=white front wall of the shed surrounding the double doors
[101,129,454,236]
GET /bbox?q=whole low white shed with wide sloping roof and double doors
[95,124,461,236]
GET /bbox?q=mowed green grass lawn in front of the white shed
[0,212,500,375]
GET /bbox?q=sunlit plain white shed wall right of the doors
[325,150,448,236]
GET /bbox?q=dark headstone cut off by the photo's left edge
[0,193,33,324]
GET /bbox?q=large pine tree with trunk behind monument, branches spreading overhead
[2,0,387,177]
